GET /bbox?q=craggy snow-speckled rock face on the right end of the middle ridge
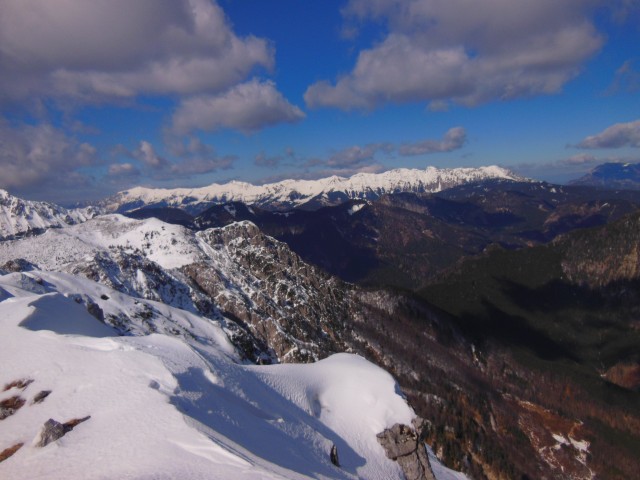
[182,222,350,362]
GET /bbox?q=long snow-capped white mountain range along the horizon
[100,166,523,214]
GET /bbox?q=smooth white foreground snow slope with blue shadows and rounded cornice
[0,271,463,480]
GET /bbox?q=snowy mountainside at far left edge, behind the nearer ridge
[0,190,100,240]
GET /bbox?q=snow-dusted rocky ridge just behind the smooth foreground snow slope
[0,214,349,363]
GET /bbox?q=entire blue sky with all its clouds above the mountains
[0,0,640,204]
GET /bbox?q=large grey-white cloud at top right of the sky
[305,0,603,110]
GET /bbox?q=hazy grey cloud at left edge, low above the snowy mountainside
[0,119,99,192]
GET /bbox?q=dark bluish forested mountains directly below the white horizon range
[194,180,640,289]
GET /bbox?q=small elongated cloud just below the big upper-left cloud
[172,79,305,134]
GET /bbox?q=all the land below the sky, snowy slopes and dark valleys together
[0,163,640,479]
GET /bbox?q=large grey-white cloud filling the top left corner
[0,0,274,102]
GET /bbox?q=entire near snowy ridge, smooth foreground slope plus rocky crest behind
[0,215,466,480]
